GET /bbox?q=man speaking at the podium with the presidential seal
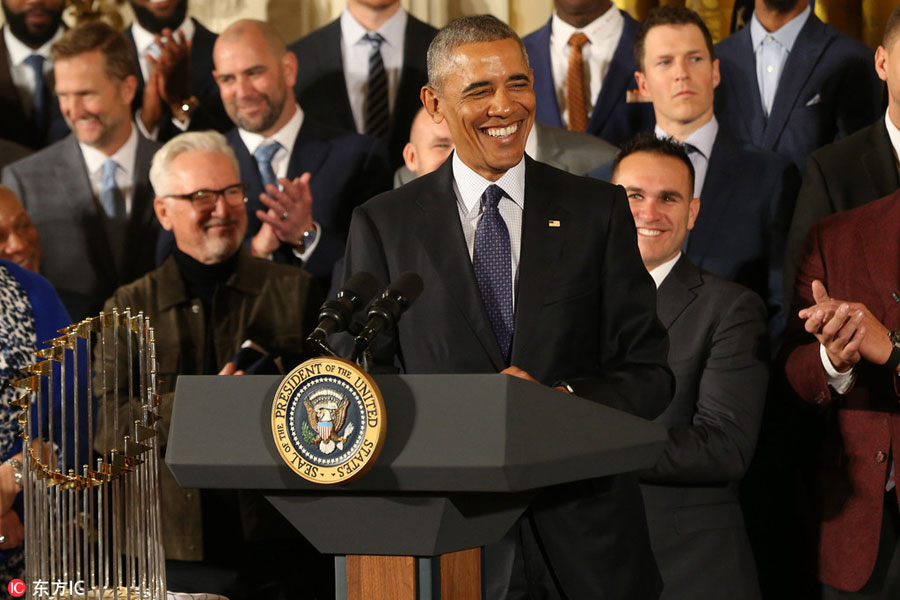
[344,15,673,600]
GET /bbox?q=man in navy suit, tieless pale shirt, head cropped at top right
[716,0,882,169]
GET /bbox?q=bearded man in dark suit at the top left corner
[0,0,69,150]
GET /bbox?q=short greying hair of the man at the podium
[426,15,528,91]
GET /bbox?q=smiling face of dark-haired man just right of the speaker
[612,152,700,271]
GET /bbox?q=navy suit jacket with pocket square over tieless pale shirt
[715,14,883,169]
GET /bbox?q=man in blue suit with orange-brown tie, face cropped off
[522,0,653,144]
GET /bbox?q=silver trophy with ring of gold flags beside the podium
[15,308,166,600]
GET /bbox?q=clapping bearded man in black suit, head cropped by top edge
[125,0,231,142]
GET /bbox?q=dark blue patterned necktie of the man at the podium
[472,185,513,361]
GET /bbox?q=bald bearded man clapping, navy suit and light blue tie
[213,20,391,289]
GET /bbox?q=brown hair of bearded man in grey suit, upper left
[50,21,138,81]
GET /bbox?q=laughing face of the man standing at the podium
[422,38,535,181]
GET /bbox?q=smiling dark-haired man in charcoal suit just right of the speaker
[612,133,768,600]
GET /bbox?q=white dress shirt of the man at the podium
[452,151,525,306]
